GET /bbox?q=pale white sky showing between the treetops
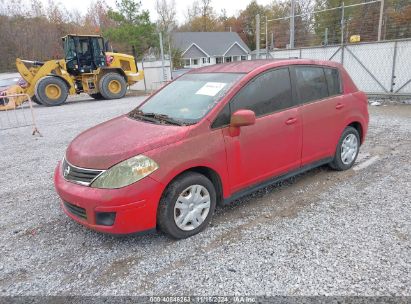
[35,0,271,24]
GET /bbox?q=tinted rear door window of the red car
[295,66,329,103]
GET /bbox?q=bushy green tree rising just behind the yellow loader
[103,0,158,55]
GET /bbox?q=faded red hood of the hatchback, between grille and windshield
[66,115,189,169]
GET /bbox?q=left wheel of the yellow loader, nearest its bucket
[34,76,68,107]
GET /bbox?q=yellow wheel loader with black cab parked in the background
[0,35,144,110]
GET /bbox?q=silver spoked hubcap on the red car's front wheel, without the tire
[174,185,211,231]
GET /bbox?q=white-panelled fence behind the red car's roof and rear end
[268,39,411,96]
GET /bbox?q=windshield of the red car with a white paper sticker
[129,73,244,124]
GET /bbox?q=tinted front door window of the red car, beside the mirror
[231,68,293,117]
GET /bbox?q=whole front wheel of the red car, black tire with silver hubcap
[157,172,217,239]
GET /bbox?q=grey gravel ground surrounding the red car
[0,97,411,296]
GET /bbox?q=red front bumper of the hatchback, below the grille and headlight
[54,162,164,234]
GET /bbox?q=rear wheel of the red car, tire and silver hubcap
[330,127,361,171]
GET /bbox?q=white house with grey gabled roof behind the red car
[172,32,251,68]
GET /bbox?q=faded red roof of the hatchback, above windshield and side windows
[189,58,339,74]
